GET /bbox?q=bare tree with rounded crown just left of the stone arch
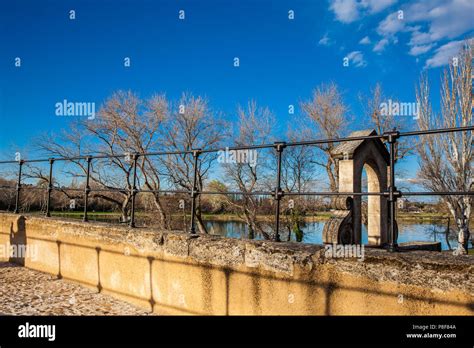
[301,83,349,192]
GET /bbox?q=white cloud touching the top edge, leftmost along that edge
[329,0,397,23]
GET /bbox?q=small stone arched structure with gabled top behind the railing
[324,130,390,245]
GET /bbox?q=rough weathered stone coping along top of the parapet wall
[0,214,474,293]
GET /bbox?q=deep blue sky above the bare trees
[0,0,474,185]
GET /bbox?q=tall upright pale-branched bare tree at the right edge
[416,43,474,254]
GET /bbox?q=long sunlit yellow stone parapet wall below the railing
[0,213,474,315]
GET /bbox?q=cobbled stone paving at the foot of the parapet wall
[0,262,149,315]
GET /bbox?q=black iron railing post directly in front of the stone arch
[384,129,401,252]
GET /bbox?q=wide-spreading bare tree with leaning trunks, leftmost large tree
[37,91,167,224]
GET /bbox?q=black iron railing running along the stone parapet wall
[0,126,474,251]
